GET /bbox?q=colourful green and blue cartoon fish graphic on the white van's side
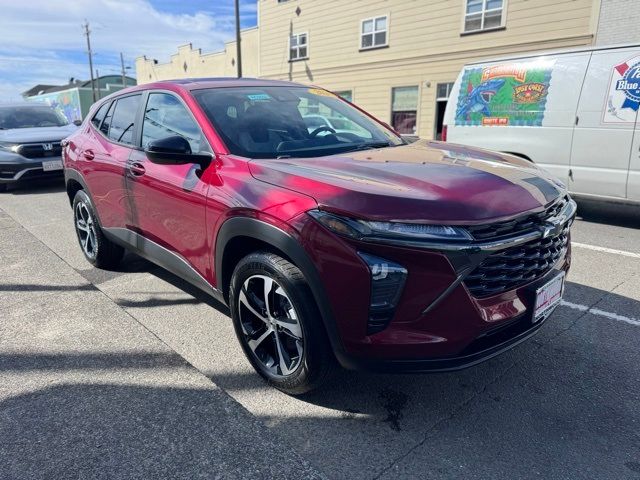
[455,60,555,127]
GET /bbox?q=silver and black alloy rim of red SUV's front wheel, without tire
[238,275,304,377]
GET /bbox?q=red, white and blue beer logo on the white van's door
[602,55,640,123]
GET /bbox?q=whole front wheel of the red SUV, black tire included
[229,252,335,395]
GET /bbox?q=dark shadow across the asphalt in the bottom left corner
[0,384,318,479]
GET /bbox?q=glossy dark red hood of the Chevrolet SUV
[249,140,566,224]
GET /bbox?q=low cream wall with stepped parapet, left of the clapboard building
[136,28,260,84]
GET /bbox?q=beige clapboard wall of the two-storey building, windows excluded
[259,0,594,138]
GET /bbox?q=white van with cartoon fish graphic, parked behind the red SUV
[443,45,640,203]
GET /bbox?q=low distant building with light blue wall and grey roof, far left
[22,75,136,122]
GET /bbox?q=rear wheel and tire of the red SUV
[73,190,124,270]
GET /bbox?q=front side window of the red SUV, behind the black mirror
[142,93,202,152]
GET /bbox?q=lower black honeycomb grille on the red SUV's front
[464,226,569,298]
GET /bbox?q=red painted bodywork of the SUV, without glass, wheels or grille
[64,80,570,368]
